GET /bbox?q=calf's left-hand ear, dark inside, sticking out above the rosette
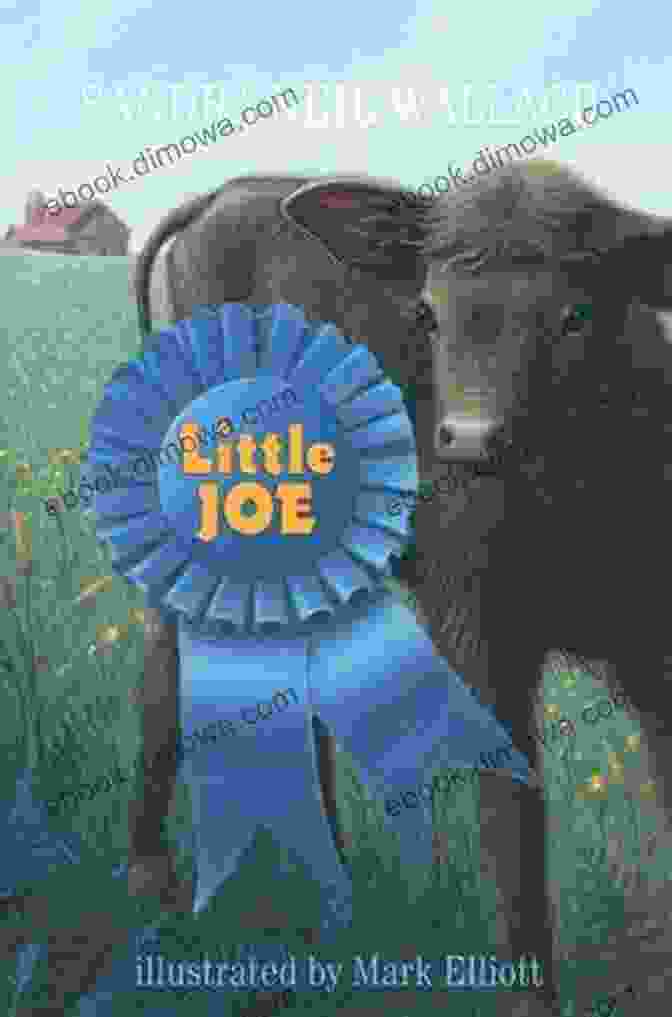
[281,179,426,282]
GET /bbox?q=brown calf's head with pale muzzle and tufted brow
[427,162,672,483]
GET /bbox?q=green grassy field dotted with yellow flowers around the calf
[0,248,672,1017]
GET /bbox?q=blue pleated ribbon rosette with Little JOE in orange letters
[88,303,528,960]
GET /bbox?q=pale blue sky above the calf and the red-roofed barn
[5,0,672,248]
